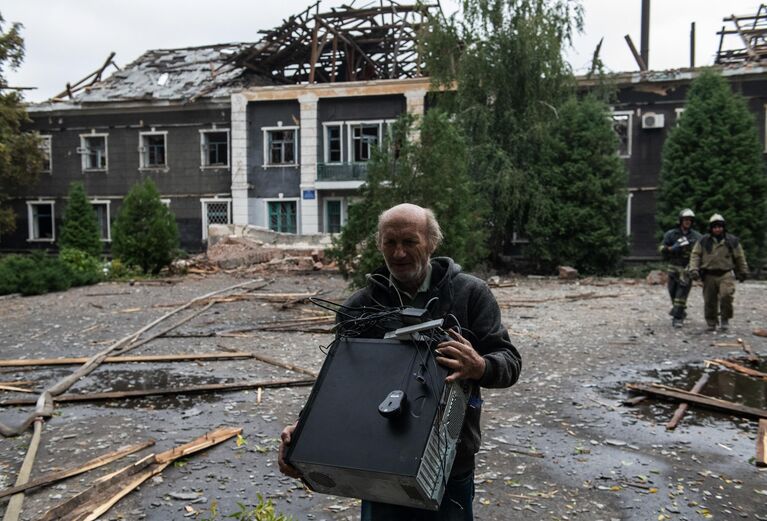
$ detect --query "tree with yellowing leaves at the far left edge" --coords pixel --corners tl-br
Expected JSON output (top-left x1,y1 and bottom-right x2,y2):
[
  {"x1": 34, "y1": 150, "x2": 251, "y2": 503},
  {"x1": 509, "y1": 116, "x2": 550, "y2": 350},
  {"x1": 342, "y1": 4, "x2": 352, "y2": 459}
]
[{"x1": 0, "y1": 15, "x2": 43, "y2": 235}]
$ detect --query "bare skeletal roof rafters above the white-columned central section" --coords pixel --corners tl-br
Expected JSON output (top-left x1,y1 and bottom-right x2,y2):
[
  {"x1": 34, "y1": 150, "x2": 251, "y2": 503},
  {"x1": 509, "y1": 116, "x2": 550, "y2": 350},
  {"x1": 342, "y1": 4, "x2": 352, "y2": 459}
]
[{"x1": 229, "y1": 0, "x2": 439, "y2": 84}]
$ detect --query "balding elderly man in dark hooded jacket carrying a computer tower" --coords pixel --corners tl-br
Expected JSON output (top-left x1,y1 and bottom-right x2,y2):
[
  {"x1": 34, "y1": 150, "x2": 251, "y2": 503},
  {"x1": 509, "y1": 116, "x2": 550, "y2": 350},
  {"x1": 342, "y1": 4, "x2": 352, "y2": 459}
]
[{"x1": 279, "y1": 204, "x2": 522, "y2": 521}]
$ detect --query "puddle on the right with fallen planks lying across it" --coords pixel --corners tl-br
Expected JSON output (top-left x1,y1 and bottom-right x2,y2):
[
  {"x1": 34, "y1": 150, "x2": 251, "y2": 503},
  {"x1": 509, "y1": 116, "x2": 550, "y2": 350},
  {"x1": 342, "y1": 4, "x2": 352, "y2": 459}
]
[{"x1": 634, "y1": 359, "x2": 767, "y2": 426}]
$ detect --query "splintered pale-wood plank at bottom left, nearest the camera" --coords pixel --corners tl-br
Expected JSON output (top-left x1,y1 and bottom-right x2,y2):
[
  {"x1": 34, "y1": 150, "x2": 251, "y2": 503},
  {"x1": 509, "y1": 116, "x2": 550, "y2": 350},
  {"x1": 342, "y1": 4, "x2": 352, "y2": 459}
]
[{"x1": 42, "y1": 427, "x2": 242, "y2": 521}]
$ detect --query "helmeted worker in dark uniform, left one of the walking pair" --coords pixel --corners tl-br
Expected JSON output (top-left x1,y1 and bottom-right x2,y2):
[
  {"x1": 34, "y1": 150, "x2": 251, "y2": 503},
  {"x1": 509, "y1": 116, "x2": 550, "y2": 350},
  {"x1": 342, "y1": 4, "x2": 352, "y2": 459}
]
[{"x1": 658, "y1": 208, "x2": 701, "y2": 327}]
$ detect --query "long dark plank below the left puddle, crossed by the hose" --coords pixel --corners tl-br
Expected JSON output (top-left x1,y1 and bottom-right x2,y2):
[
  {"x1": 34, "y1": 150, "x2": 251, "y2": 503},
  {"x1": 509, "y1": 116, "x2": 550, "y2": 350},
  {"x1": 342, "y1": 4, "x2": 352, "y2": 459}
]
[{"x1": 0, "y1": 378, "x2": 314, "y2": 407}]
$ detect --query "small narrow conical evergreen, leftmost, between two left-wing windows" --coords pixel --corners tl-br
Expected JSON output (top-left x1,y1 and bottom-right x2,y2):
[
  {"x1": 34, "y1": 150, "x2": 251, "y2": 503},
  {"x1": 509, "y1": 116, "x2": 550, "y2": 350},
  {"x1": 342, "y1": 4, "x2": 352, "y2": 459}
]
[{"x1": 58, "y1": 182, "x2": 103, "y2": 257}]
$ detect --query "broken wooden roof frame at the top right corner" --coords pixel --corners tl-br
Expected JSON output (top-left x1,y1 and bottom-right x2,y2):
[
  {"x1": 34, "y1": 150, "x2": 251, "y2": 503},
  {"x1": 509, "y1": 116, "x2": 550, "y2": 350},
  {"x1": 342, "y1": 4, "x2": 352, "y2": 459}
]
[{"x1": 715, "y1": 4, "x2": 767, "y2": 65}]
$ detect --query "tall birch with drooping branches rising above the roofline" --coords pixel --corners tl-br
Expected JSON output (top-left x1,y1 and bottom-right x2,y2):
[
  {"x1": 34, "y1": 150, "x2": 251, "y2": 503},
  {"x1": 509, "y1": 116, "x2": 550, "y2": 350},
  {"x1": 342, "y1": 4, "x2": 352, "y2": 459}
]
[{"x1": 425, "y1": 0, "x2": 582, "y2": 255}]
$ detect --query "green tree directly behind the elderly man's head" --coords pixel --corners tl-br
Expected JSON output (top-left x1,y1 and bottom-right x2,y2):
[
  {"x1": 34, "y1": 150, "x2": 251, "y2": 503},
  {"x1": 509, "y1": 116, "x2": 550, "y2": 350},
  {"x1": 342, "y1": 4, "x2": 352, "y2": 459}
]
[{"x1": 330, "y1": 109, "x2": 486, "y2": 286}]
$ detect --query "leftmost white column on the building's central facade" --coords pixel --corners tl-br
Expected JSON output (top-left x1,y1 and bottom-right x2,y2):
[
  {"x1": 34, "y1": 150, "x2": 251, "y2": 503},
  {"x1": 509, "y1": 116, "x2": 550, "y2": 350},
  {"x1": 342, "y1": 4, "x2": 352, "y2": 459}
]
[{"x1": 230, "y1": 94, "x2": 250, "y2": 225}]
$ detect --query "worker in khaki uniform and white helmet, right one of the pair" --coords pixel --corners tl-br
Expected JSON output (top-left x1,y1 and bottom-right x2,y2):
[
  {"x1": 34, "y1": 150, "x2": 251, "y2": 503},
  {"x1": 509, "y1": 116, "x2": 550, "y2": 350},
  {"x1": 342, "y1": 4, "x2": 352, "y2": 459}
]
[{"x1": 689, "y1": 213, "x2": 748, "y2": 331}]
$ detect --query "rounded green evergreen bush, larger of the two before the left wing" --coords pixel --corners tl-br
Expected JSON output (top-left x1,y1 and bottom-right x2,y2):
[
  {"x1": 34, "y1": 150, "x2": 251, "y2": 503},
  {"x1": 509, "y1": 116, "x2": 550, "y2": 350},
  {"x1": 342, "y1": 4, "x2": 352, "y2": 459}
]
[{"x1": 112, "y1": 178, "x2": 179, "y2": 274}]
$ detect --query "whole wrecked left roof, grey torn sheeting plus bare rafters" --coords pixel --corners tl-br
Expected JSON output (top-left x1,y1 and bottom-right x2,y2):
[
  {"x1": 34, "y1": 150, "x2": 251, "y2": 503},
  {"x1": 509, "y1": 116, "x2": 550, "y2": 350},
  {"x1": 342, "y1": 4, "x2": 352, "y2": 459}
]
[{"x1": 49, "y1": 0, "x2": 439, "y2": 105}]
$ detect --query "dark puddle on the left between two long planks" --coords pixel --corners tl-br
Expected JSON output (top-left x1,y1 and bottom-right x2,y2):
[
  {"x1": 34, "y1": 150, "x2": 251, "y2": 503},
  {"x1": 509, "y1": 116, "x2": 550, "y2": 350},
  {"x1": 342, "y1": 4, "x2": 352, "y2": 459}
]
[{"x1": 73, "y1": 369, "x2": 234, "y2": 409}]
